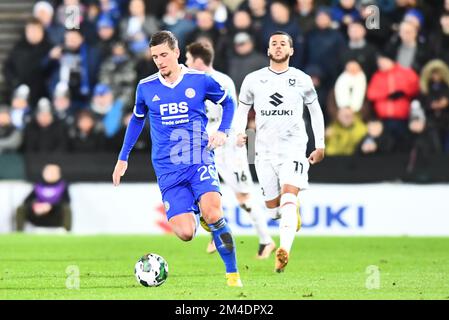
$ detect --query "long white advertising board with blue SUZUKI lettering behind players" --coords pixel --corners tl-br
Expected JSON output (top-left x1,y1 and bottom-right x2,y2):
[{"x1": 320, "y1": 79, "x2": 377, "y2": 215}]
[{"x1": 0, "y1": 182, "x2": 449, "y2": 236}]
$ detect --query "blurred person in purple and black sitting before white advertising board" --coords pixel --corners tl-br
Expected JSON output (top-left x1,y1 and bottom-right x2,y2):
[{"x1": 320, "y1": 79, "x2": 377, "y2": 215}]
[{"x1": 16, "y1": 164, "x2": 72, "y2": 231}]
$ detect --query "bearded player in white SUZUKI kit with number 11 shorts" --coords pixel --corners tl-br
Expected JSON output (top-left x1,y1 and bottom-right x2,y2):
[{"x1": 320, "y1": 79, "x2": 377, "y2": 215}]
[{"x1": 234, "y1": 31, "x2": 324, "y2": 272}]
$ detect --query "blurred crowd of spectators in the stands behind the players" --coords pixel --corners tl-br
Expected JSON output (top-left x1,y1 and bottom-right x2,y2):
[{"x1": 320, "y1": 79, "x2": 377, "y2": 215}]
[{"x1": 0, "y1": 0, "x2": 449, "y2": 156}]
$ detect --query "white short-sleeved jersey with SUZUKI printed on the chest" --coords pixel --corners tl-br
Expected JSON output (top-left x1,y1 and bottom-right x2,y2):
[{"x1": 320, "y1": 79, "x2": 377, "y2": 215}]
[{"x1": 239, "y1": 67, "x2": 318, "y2": 157}]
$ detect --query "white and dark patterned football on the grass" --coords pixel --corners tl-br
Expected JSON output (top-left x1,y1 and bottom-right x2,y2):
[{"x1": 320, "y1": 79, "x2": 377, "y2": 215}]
[{"x1": 134, "y1": 253, "x2": 168, "y2": 287}]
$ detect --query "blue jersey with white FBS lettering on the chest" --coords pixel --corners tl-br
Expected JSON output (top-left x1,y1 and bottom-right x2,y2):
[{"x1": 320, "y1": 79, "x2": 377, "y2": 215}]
[{"x1": 134, "y1": 66, "x2": 227, "y2": 177}]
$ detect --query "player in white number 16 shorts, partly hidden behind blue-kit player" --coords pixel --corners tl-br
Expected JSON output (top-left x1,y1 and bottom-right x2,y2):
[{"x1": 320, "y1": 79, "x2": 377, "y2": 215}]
[{"x1": 186, "y1": 40, "x2": 276, "y2": 259}]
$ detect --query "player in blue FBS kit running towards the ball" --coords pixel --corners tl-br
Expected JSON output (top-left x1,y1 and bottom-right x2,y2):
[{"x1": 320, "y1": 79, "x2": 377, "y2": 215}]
[{"x1": 112, "y1": 31, "x2": 242, "y2": 287}]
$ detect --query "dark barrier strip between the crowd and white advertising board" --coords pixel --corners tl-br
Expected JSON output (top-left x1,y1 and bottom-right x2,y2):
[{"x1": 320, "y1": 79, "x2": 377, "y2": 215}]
[{"x1": 0, "y1": 152, "x2": 449, "y2": 183}]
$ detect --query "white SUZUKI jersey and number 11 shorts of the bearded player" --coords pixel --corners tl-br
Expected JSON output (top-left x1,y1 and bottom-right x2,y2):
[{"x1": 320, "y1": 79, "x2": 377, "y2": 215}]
[{"x1": 240, "y1": 67, "x2": 324, "y2": 200}]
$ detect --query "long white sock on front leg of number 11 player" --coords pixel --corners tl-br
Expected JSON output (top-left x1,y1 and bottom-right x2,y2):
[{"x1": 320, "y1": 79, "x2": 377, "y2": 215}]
[{"x1": 279, "y1": 193, "x2": 298, "y2": 252}]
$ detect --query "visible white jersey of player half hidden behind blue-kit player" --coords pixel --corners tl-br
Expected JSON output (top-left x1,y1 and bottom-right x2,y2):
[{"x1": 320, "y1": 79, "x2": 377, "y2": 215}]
[{"x1": 205, "y1": 70, "x2": 237, "y2": 135}]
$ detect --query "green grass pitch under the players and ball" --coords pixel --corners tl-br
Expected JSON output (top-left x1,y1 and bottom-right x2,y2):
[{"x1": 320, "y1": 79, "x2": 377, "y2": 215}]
[{"x1": 0, "y1": 234, "x2": 449, "y2": 300}]
